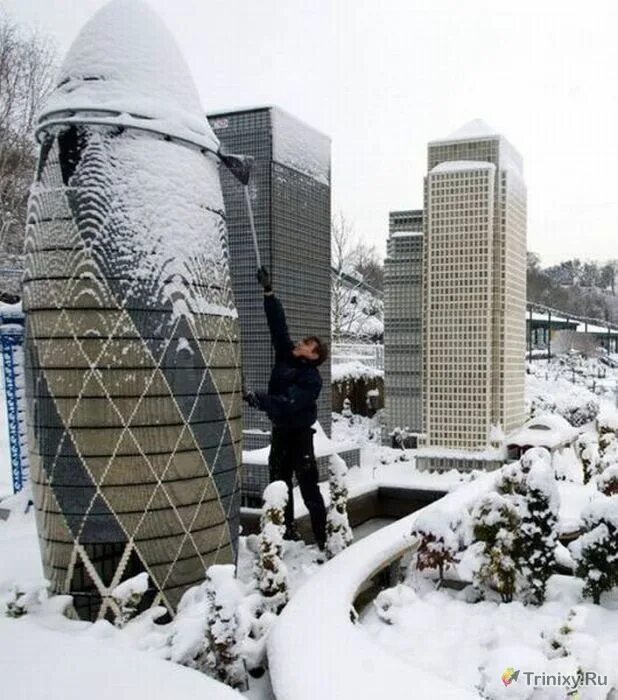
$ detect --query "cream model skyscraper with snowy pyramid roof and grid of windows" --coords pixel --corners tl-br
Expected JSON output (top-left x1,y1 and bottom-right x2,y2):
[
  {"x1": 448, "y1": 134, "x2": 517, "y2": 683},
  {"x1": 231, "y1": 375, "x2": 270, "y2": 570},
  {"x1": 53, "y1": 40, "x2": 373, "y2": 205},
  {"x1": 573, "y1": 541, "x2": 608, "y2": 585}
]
[{"x1": 423, "y1": 120, "x2": 526, "y2": 450}]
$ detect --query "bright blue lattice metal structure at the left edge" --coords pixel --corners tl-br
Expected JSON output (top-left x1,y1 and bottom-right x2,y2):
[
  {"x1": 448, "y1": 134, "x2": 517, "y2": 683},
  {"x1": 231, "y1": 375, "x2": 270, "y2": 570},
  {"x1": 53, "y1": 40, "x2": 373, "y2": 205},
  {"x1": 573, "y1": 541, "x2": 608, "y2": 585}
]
[{"x1": 0, "y1": 307, "x2": 28, "y2": 493}]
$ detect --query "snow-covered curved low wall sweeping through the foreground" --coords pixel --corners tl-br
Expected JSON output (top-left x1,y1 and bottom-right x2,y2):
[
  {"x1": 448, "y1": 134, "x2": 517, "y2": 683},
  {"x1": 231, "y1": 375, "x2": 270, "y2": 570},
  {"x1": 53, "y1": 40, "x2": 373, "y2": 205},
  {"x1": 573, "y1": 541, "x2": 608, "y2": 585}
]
[{"x1": 268, "y1": 472, "x2": 495, "y2": 700}]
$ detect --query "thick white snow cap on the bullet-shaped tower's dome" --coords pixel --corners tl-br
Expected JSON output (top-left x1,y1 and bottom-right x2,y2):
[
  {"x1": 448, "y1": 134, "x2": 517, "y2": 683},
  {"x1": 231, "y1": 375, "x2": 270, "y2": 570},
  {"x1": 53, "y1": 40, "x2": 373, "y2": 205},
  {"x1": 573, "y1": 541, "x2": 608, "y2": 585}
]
[{"x1": 38, "y1": 0, "x2": 219, "y2": 152}]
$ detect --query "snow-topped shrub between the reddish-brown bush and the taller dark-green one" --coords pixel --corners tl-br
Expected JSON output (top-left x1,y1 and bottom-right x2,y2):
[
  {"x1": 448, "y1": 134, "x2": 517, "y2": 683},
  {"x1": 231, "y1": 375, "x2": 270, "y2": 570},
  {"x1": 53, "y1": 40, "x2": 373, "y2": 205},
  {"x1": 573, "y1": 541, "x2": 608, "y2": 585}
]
[{"x1": 472, "y1": 493, "x2": 521, "y2": 603}]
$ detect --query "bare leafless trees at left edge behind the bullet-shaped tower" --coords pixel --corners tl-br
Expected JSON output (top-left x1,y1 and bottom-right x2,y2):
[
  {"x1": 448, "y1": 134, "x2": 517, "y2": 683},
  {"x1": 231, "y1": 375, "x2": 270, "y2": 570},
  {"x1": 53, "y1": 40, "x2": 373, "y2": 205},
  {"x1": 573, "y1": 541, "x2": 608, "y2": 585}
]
[{"x1": 0, "y1": 12, "x2": 56, "y2": 288}]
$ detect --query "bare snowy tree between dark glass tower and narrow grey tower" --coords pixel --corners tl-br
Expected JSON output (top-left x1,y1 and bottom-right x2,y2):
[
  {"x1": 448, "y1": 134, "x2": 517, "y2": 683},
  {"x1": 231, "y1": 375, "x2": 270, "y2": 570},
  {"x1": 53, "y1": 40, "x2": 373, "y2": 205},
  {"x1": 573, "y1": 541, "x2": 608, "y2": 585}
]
[{"x1": 331, "y1": 213, "x2": 383, "y2": 342}]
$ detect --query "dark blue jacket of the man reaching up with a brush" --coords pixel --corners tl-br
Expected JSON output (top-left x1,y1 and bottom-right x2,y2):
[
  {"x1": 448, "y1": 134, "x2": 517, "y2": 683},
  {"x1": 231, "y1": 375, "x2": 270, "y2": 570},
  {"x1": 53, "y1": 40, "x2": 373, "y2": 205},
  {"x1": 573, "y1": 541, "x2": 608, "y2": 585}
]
[{"x1": 255, "y1": 294, "x2": 322, "y2": 428}]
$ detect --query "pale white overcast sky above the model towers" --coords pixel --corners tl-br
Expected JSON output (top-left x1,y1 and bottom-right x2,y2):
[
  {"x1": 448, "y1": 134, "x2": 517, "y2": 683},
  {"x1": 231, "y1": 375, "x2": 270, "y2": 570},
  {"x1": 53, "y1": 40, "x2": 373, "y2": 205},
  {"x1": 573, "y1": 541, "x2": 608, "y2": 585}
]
[{"x1": 0, "y1": 0, "x2": 618, "y2": 264}]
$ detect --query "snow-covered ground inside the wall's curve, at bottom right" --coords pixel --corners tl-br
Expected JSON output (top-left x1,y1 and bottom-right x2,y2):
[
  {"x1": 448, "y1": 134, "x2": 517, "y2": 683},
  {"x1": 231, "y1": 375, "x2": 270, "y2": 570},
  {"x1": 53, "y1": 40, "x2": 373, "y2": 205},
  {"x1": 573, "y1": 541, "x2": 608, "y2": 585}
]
[{"x1": 363, "y1": 576, "x2": 618, "y2": 700}]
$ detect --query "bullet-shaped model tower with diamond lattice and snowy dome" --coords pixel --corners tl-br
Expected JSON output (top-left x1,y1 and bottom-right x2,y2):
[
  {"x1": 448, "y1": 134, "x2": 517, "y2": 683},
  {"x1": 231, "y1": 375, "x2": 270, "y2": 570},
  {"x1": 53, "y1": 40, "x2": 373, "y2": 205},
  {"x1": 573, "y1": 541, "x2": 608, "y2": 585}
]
[{"x1": 24, "y1": 0, "x2": 241, "y2": 618}]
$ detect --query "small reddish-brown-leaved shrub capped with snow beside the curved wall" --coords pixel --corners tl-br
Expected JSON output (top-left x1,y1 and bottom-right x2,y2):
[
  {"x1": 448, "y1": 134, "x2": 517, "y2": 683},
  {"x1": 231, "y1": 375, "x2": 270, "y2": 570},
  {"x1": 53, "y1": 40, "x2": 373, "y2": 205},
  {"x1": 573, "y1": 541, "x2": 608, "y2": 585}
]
[{"x1": 412, "y1": 510, "x2": 459, "y2": 585}]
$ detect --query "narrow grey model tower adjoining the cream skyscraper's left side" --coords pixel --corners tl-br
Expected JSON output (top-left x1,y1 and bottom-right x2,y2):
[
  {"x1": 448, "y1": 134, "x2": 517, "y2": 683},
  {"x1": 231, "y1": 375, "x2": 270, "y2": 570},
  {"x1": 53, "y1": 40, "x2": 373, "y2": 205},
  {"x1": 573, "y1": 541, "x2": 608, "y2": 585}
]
[{"x1": 384, "y1": 210, "x2": 423, "y2": 446}]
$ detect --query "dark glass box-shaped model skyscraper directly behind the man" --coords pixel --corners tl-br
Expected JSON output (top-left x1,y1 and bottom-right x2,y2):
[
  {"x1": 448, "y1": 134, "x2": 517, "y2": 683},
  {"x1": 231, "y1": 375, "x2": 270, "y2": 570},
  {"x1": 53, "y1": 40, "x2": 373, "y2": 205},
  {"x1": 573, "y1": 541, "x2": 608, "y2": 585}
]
[{"x1": 209, "y1": 107, "x2": 332, "y2": 505}]
